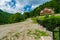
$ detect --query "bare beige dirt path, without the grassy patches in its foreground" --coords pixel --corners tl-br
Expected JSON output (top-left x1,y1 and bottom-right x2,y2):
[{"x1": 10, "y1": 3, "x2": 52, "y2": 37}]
[{"x1": 0, "y1": 19, "x2": 52, "y2": 40}]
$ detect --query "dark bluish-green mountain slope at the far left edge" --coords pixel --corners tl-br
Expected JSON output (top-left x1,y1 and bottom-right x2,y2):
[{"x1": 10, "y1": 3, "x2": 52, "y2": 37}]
[{"x1": 0, "y1": 10, "x2": 11, "y2": 24}]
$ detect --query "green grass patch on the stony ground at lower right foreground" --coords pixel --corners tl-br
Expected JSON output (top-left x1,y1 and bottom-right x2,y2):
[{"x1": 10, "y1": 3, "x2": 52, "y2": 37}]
[{"x1": 27, "y1": 29, "x2": 48, "y2": 39}]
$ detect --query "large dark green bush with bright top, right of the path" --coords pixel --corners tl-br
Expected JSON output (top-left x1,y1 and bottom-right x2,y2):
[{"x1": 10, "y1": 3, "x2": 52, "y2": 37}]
[{"x1": 37, "y1": 15, "x2": 60, "y2": 31}]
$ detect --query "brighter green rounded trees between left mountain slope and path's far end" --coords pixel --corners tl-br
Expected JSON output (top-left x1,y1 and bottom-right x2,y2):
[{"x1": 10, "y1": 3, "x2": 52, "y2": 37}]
[{"x1": 8, "y1": 13, "x2": 23, "y2": 23}]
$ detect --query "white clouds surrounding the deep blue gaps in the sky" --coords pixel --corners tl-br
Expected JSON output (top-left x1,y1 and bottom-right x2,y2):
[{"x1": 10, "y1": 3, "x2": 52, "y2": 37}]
[{"x1": 0, "y1": 0, "x2": 50, "y2": 13}]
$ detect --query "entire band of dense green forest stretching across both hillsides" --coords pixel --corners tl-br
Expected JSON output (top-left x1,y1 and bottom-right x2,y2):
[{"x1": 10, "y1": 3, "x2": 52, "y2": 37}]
[{"x1": 0, "y1": 0, "x2": 60, "y2": 24}]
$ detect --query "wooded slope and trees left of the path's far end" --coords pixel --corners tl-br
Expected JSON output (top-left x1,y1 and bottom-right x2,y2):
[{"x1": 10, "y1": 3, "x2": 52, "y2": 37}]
[{"x1": 0, "y1": 10, "x2": 30, "y2": 24}]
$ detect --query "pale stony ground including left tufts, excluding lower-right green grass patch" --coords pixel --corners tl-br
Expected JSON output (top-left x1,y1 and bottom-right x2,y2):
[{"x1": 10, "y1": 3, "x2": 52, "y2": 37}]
[{"x1": 0, "y1": 19, "x2": 53, "y2": 40}]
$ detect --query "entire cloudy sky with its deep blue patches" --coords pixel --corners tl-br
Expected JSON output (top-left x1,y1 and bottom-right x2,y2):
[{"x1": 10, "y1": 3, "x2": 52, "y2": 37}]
[{"x1": 0, "y1": 0, "x2": 49, "y2": 13}]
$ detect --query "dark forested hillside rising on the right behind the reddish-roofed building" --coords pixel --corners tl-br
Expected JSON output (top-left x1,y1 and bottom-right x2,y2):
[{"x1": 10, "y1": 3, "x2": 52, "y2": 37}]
[{"x1": 31, "y1": 0, "x2": 60, "y2": 16}]
